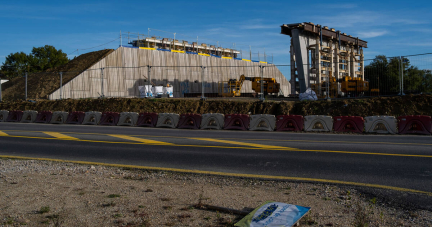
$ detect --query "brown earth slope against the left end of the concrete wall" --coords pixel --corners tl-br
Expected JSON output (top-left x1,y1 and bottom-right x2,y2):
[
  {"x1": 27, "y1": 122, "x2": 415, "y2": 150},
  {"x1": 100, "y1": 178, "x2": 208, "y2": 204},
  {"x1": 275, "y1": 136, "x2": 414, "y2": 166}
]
[{"x1": 2, "y1": 49, "x2": 114, "y2": 101}]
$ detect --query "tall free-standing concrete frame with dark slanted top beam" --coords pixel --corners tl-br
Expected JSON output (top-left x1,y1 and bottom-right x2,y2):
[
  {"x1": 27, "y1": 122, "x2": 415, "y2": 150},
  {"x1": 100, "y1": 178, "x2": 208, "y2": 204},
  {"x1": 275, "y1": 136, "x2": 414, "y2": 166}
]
[{"x1": 281, "y1": 22, "x2": 367, "y2": 96}]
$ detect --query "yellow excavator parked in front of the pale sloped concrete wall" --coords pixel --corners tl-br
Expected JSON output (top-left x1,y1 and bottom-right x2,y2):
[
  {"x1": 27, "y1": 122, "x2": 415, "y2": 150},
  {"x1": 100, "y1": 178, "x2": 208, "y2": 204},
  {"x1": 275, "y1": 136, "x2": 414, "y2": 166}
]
[{"x1": 218, "y1": 75, "x2": 280, "y2": 97}]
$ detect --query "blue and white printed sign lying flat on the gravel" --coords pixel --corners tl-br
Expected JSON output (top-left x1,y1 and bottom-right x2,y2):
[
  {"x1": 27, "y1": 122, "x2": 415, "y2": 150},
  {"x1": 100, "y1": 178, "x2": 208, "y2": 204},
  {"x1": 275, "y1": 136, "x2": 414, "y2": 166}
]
[{"x1": 234, "y1": 201, "x2": 310, "y2": 227}]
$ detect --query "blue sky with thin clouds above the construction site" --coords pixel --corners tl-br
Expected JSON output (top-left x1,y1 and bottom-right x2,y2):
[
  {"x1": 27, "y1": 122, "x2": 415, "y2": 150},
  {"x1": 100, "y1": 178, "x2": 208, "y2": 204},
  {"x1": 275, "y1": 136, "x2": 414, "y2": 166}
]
[{"x1": 0, "y1": 0, "x2": 432, "y2": 68}]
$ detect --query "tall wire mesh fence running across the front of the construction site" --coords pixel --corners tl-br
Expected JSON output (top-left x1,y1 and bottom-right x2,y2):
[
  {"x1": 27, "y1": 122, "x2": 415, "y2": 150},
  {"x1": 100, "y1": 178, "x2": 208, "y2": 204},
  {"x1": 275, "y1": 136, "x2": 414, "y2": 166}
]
[{"x1": 1, "y1": 54, "x2": 432, "y2": 100}]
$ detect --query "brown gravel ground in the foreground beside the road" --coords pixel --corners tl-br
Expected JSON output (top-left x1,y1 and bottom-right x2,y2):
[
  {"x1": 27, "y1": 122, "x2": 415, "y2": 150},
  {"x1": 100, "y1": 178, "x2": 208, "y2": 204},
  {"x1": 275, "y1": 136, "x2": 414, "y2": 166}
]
[{"x1": 0, "y1": 159, "x2": 432, "y2": 226}]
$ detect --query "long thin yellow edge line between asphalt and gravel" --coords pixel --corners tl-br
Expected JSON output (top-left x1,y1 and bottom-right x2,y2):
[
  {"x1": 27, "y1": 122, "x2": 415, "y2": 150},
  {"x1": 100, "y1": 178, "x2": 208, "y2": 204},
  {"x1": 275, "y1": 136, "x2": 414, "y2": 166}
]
[{"x1": 0, "y1": 155, "x2": 432, "y2": 196}]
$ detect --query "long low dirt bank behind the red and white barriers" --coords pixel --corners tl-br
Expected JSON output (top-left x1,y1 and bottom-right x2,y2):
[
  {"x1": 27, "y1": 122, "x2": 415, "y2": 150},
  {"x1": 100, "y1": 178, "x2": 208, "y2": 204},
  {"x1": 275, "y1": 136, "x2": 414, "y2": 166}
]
[{"x1": 0, "y1": 95, "x2": 432, "y2": 116}]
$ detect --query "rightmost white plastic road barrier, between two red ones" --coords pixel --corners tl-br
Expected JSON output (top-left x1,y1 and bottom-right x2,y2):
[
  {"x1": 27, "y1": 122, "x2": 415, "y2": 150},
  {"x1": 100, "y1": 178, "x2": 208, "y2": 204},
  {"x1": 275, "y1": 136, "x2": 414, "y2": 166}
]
[{"x1": 365, "y1": 116, "x2": 398, "y2": 134}]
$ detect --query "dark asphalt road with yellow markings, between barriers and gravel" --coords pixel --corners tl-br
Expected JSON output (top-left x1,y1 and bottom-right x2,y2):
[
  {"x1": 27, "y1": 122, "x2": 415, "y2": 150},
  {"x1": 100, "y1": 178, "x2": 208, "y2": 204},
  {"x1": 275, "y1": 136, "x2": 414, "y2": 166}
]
[{"x1": 0, "y1": 122, "x2": 432, "y2": 208}]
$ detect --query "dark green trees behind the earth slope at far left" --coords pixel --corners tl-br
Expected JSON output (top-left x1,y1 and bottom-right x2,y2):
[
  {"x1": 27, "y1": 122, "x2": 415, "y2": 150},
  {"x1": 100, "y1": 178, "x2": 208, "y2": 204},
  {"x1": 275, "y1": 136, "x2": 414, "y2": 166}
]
[{"x1": 1, "y1": 45, "x2": 69, "y2": 78}]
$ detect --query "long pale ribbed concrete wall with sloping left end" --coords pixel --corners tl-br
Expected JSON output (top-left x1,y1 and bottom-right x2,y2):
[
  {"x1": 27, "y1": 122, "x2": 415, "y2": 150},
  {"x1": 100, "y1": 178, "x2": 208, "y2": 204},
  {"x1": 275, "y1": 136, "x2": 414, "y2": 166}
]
[{"x1": 48, "y1": 47, "x2": 290, "y2": 100}]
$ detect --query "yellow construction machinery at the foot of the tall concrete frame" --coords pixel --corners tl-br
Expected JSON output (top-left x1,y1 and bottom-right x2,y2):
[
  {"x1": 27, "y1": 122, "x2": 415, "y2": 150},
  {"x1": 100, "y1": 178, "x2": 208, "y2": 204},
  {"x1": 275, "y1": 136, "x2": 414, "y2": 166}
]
[{"x1": 311, "y1": 72, "x2": 379, "y2": 98}]
